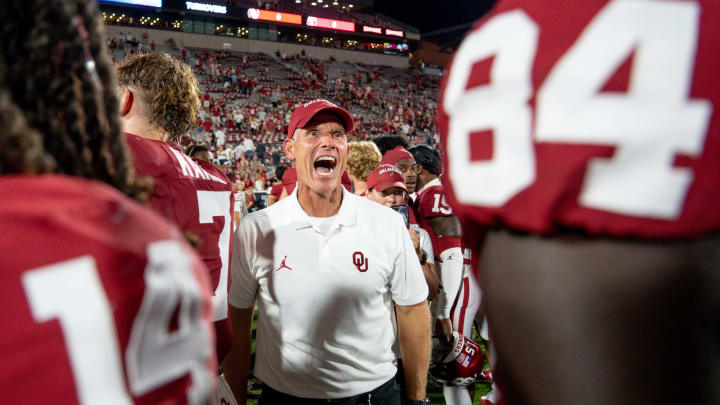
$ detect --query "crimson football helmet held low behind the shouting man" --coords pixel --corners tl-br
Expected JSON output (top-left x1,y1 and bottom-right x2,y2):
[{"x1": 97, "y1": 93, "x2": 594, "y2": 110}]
[{"x1": 429, "y1": 332, "x2": 483, "y2": 386}]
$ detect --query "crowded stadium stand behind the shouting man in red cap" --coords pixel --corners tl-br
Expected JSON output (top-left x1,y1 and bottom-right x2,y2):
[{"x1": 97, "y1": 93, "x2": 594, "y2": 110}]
[{"x1": 108, "y1": 37, "x2": 438, "y2": 200}]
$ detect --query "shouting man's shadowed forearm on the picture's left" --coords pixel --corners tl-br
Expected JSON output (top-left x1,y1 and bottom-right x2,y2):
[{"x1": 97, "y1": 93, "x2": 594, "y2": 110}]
[{"x1": 222, "y1": 304, "x2": 254, "y2": 404}]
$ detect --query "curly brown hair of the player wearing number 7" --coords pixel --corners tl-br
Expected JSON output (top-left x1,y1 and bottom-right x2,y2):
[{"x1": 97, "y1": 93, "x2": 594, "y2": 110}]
[{"x1": 118, "y1": 52, "x2": 200, "y2": 142}]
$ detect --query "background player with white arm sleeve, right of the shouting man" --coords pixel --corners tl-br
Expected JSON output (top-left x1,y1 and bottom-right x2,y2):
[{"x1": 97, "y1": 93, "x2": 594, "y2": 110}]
[{"x1": 408, "y1": 145, "x2": 481, "y2": 405}]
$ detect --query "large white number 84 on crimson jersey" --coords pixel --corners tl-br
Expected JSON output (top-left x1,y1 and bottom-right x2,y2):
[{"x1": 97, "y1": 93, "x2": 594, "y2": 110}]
[{"x1": 444, "y1": 0, "x2": 712, "y2": 219}]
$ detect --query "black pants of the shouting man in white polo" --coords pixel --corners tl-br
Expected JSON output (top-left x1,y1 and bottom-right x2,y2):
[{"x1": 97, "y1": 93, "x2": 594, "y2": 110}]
[{"x1": 258, "y1": 378, "x2": 400, "y2": 405}]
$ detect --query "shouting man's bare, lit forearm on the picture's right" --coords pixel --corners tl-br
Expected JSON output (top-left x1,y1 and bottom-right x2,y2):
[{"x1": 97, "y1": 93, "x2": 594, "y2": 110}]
[{"x1": 395, "y1": 301, "x2": 430, "y2": 400}]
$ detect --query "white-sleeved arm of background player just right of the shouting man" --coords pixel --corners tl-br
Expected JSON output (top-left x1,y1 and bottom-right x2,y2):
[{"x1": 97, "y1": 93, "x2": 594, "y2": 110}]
[{"x1": 430, "y1": 215, "x2": 463, "y2": 338}]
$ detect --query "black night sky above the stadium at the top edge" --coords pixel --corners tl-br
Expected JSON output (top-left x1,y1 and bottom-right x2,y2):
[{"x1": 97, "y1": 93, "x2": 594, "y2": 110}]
[{"x1": 375, "y1": 0, "x2": 495, "y2": 33}]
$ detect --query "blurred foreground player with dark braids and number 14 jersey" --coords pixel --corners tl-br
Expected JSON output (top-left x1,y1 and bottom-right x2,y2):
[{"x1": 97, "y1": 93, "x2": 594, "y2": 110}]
[{"x1": 0, "y1": 0, "x2": 216, "y2": 404}]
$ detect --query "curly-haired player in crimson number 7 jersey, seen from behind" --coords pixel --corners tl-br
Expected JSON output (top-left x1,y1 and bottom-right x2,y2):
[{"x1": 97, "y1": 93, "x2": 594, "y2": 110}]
[{"x1": 117, "y1": 52, "x2": 233, "y2": 361}]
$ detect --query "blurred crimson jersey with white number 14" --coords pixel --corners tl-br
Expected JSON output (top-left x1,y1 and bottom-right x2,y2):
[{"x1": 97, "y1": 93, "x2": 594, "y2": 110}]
[{"x1": 0, "y1": 175, "x2": 216, "y2": 405}]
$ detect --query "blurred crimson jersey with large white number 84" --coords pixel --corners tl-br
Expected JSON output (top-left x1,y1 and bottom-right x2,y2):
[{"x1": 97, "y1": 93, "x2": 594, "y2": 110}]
[{"x1": 438, "y1": 0, "x2": 720, "y2": 238}]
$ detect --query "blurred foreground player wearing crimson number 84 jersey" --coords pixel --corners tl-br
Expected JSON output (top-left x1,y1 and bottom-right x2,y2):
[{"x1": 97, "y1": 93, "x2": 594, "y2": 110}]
[{"x1": 438, "y1": 0, "x2": 720, "y2": 405}]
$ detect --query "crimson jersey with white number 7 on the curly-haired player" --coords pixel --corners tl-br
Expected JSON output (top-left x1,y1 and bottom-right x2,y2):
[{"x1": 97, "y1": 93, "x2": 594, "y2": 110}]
[{"x1": 126, "y1": 134, "x2": 234, "y2": 320}]
